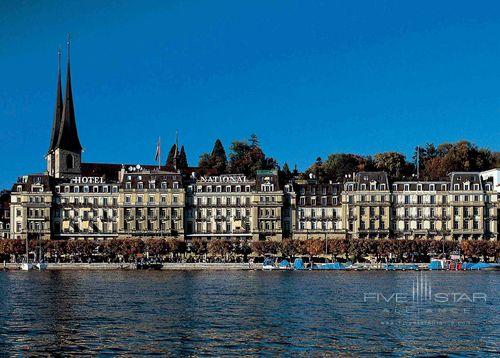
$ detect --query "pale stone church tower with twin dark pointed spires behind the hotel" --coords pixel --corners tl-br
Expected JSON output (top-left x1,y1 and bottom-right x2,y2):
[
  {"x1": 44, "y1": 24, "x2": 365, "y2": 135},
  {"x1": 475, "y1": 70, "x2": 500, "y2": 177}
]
[{"x1": 47, "y1": 39, "x2": 82, "y2": 178}]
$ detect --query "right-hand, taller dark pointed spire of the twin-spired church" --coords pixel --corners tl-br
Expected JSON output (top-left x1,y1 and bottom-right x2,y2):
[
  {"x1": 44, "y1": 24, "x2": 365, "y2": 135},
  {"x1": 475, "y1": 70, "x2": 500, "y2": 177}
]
[{"x1": 56, "y1": 36, "x2": 82, "y2": 152}]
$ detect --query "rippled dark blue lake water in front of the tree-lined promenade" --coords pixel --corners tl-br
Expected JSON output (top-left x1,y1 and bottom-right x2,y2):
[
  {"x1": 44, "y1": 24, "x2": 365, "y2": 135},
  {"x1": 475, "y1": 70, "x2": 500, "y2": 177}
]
[{"x1": 0, "y1": 271, "x2": 500, "y2": 356}]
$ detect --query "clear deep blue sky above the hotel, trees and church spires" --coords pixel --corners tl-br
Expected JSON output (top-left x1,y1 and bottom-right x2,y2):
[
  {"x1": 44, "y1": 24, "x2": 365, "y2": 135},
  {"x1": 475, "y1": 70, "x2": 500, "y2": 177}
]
[{"x1": 0, "y1": 0, "x2": 500, "y2": 187}]
